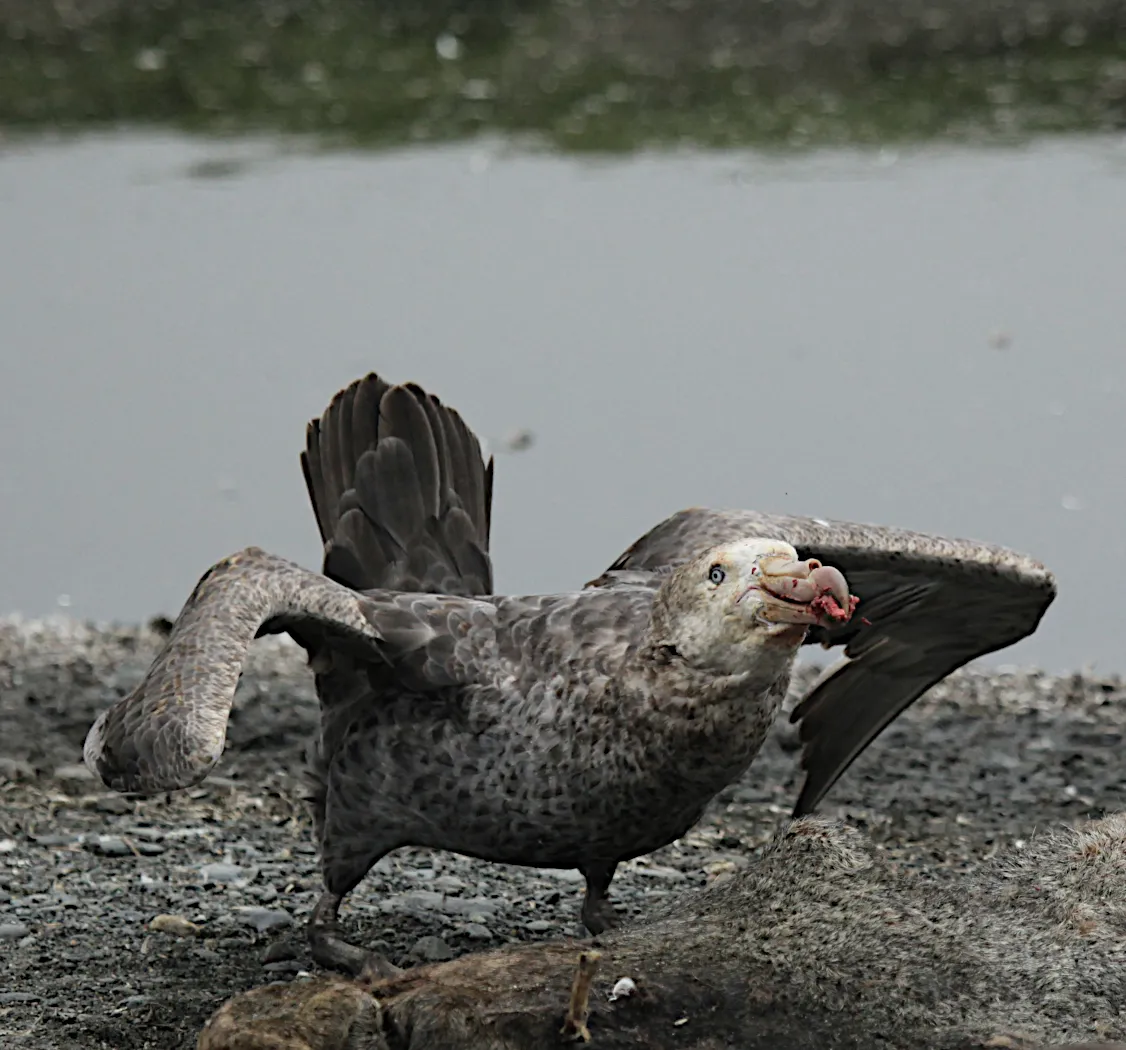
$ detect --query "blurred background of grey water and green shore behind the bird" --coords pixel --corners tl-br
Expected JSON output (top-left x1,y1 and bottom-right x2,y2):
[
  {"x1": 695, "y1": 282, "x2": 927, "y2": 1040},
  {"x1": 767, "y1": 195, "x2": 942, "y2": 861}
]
[{"x1": 0, "y1": 0, "x2": 1126, "y2": 673}]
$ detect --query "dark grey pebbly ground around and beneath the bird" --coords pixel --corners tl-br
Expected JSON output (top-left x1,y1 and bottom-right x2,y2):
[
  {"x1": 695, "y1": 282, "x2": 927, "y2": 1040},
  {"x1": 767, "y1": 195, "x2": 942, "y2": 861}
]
[{"x1": 0, "y1": 622, "x2": 1126, "y2": 1050}]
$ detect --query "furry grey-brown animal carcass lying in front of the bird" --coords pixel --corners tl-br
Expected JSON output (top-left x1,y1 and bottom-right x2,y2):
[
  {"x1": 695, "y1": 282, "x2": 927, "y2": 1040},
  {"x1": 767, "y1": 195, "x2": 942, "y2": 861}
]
[{"x1": 199, "y1": 815, "x2": 1126, "y2": 1050}]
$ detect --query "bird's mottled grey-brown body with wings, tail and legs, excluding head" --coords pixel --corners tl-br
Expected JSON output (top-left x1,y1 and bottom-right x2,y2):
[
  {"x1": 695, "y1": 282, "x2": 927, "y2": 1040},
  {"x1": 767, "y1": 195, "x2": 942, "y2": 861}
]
[{"x1": 86, "y1": 375, "x2": 1054, "y2": 968}]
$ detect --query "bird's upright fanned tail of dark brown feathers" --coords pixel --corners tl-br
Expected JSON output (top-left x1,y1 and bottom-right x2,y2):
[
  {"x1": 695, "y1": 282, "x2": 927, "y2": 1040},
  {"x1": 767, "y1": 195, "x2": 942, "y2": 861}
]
[{"x1": 301, "y1": 373, "x2": 493, "y2": 595}]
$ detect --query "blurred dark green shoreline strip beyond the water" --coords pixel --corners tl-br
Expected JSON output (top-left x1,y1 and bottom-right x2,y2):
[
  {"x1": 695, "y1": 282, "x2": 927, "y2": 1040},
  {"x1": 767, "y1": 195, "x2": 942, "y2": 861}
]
[{"x1": 0, "y1": 0, "x2": 1126, "y2": 151}]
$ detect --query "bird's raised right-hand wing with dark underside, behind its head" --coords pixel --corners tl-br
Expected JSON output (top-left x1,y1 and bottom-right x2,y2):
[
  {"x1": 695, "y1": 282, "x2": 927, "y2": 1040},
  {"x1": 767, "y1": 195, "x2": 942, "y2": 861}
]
[{"x1": 595, "y1": 508, "x2": 1056, "y2": 816}]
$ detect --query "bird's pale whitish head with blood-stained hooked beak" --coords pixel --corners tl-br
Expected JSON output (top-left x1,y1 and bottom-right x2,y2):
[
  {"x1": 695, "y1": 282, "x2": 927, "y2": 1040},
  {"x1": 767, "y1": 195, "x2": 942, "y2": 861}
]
[{"x1": 654, "y1": 538, "x2": 858, "y2": 674}]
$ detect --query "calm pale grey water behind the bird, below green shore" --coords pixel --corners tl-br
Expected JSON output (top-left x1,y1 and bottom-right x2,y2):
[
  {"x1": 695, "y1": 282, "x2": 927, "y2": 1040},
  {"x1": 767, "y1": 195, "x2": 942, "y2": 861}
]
[{"x1": 0, "y1": 134, "x2": 1126, "y2": 673}]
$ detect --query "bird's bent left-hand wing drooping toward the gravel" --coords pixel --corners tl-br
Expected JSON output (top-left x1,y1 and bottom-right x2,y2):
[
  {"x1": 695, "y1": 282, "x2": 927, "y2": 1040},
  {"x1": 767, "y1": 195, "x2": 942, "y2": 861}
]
[{"x1": 83, "y1": 547, "x2": 495, "y2": 793}]
